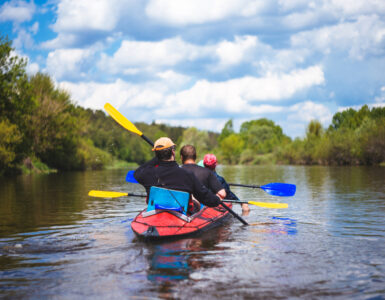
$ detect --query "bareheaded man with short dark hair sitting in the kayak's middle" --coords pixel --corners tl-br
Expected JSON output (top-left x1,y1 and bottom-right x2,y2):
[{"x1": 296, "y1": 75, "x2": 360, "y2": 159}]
[{"x1": 180, "y1": 145, "x2": 226, "y2": 199}]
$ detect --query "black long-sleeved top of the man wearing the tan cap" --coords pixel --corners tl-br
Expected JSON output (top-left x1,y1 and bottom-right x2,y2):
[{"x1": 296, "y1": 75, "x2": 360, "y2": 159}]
[{"x1": 134, "y1": 157, "x2": 220, "y2": 207}]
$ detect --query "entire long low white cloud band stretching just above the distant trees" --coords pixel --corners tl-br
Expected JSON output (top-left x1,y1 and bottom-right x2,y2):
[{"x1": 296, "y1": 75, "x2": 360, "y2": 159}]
[{"x1": 57, "y1": 66, "x2": 323, "y2": 125}]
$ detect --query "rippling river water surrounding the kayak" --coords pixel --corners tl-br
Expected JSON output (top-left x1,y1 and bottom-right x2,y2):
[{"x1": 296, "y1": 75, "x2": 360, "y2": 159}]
[{"x1": 0, "y1": 166, "x2": 385, "y2": 299}]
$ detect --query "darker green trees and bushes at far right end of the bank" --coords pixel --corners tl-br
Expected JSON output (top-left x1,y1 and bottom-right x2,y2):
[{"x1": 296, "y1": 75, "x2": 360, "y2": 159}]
[{"x1": 279, "y1": 105, "x2": 385, "y2": 165}]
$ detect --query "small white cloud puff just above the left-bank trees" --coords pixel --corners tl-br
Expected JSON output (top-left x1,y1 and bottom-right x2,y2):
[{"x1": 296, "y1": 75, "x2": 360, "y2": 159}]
[{"x1": 46, "y1": 49, "x2": 94, "y2": 79}]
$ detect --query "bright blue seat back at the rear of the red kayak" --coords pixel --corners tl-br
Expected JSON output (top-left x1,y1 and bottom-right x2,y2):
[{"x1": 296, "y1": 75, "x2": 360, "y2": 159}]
[{"x1": 147, "y1": 186, "x2": 190, "y2": 215}]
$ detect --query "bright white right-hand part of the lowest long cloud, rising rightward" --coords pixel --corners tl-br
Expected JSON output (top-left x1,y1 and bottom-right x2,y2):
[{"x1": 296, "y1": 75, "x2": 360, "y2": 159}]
[{"x1": 156, "y1": 66, "x2": 324, "y2": 117}]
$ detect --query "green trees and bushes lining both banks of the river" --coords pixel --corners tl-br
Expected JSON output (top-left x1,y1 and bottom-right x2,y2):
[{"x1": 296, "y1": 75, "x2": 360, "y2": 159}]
[{"x1": 0, "y1": 36, "x2": 385, "y2": 176}]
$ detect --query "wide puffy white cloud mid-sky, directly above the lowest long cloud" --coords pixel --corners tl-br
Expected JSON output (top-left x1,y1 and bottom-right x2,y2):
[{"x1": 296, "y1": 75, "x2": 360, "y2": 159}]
[{"x1": 98, "y1": 35, "x2": 310, "y2": 75}]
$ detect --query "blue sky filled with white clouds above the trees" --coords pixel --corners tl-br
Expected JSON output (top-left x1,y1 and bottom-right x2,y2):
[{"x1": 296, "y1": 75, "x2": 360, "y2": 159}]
[{"x1": 0, "y1": 0, "x2": 385, "y2": 138}]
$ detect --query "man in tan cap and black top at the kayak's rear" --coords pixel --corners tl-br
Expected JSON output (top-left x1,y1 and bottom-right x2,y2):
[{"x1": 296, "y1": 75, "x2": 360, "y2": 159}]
[{"x1": 134, "y1": 137, "x2": 221, "y2": 213}]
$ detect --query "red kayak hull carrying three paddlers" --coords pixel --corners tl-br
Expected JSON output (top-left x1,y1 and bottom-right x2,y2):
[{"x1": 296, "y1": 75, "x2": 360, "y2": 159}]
[{"x1": 131, "y1": 204, "x2": 232, "y2": 240}]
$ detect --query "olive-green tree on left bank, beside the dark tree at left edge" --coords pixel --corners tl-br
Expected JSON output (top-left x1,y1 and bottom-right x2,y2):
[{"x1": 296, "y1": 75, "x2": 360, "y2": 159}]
[{"x1": 30, "y1": 73, "x2": 84, "y2": 170}]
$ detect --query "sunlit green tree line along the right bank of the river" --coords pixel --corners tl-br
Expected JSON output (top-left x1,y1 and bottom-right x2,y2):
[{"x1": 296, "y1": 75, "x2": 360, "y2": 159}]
[{"x1": 214, "y1": 105, "x2": 385, "y2": 165}]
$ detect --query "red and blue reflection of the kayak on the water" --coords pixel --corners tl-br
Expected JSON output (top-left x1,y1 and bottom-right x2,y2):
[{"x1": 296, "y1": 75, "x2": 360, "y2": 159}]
[{"x1": 147, "y1": 227, "x2": 230, "y2": 286}]
